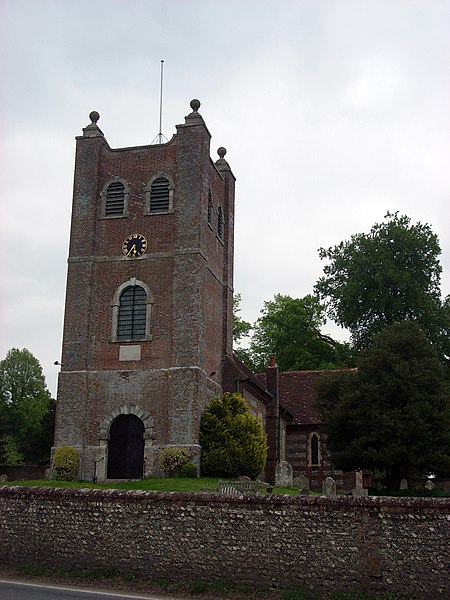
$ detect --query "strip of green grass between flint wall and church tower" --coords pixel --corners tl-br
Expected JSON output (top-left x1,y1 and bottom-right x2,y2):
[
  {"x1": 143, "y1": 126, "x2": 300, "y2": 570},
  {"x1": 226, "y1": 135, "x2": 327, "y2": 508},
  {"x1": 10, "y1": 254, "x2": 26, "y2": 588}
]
[{"x1": 3, "y1": 477, "x2": 304, "y2": 495}]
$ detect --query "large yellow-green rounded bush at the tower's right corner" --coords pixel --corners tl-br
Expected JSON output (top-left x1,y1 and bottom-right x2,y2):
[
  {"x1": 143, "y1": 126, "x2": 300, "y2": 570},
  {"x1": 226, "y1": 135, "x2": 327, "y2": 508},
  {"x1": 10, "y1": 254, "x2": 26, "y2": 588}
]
[{"x1": 200, "y1": 394, "x2": 267, "y2": 479}]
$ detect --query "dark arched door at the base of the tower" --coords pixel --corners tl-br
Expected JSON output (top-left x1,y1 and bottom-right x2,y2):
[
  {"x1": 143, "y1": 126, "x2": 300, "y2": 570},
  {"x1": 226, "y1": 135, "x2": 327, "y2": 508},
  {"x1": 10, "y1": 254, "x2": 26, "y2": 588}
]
[{"x1": 107, "y1": 415, "x2": 145, "y2": 479}]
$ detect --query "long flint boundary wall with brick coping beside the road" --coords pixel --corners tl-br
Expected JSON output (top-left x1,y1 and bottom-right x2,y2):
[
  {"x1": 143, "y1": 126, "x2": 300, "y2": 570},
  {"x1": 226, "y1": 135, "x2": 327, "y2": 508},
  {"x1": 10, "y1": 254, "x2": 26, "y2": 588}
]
[{"x1": 0, "y1": 486, "x2": 450, "y2": 600}]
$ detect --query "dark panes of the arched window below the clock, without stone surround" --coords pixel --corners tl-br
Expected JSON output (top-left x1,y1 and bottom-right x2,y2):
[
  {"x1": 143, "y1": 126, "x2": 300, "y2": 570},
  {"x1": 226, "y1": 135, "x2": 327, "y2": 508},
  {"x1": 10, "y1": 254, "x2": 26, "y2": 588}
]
[{"x1": 117, "y1": 285, "x2": 147, "y2": 340}]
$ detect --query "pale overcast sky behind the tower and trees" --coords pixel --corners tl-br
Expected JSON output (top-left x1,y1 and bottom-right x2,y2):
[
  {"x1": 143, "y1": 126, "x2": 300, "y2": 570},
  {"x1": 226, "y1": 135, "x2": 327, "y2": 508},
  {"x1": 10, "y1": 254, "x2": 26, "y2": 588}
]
[{"x1": 0, "y1": 0, "x2": 450, "y2": 394}]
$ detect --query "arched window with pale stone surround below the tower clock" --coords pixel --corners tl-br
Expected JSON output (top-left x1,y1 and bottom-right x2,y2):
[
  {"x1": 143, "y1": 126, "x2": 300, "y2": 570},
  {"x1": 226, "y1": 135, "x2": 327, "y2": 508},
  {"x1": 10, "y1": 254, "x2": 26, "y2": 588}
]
[{"x1": 112, "y1": 277, "x2": 153, "y2": 341}]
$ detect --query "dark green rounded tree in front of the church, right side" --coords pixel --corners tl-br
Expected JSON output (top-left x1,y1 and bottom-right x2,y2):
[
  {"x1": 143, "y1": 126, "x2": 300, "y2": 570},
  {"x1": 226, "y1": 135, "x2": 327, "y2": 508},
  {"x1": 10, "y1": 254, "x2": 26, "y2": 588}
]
[{"x1": 317, "y1": 321, "x2": 450, "y2": 488}]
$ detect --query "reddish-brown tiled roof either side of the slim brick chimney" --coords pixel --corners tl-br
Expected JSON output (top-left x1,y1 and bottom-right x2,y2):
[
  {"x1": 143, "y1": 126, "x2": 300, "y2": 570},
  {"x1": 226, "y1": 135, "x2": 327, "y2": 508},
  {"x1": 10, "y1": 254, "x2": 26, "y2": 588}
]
[{"x1": 257, "y1": 370, "x2": 342, "y2": 425}]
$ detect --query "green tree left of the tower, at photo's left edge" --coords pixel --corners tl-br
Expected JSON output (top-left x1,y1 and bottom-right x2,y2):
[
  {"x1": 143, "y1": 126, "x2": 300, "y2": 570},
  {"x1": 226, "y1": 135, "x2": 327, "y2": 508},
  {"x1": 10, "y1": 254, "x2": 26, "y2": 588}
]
[{"x1": 0, "y1": 348, "x2": 54, "y2": 463}]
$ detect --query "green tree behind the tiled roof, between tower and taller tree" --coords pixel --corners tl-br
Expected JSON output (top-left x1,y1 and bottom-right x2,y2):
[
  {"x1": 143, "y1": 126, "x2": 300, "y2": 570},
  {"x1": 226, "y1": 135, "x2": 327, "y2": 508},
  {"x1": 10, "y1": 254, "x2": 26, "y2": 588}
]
[{"x1": 250, "y1": 294, "x2": 352, "y2": 371}]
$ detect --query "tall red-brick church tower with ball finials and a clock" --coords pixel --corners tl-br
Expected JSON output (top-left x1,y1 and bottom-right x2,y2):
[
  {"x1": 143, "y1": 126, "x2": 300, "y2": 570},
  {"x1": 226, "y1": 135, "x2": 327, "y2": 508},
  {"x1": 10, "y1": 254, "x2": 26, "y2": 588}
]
[{"x1": 55, "y1": 100, "x2": 235, "y2": 481}]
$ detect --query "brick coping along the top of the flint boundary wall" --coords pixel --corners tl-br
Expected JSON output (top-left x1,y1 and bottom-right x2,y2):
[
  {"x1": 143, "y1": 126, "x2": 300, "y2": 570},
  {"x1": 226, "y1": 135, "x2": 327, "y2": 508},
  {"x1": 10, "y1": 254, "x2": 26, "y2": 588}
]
[{"x1": 0, "y1": 485, "x2": 450, "y2": 514}]
